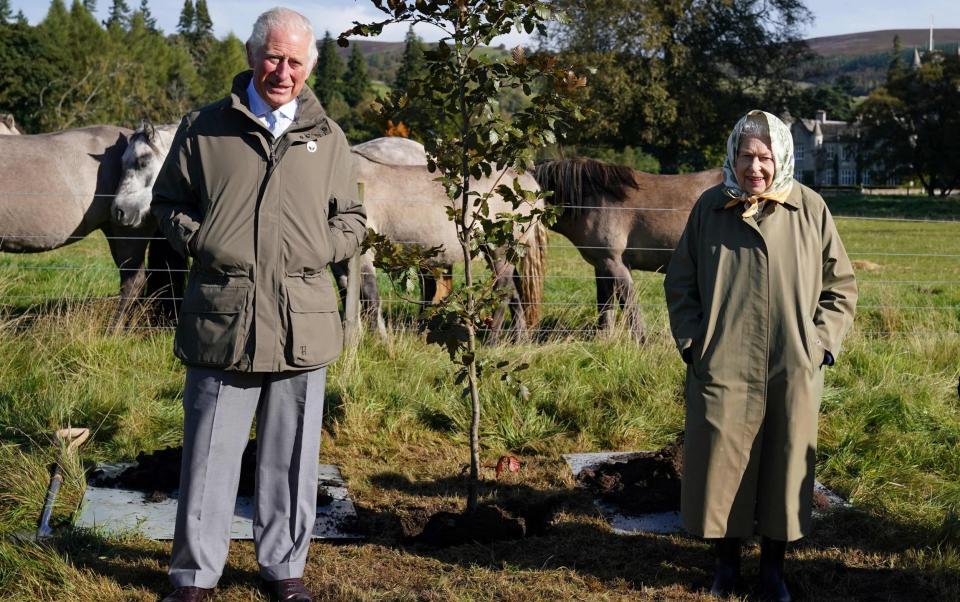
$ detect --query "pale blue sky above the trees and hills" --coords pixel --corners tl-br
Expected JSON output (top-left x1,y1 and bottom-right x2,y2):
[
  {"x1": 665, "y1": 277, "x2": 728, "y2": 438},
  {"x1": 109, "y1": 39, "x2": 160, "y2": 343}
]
[{"x1": 11, "y1": 0, "x2": 960, "y2": 47}]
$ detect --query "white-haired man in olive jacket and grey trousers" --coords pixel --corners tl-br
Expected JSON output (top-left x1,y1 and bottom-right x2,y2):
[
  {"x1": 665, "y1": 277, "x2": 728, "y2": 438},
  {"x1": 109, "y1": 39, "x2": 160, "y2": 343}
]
[{"x1": 151, "y1": 8, "x2": 366, "y2": 602}]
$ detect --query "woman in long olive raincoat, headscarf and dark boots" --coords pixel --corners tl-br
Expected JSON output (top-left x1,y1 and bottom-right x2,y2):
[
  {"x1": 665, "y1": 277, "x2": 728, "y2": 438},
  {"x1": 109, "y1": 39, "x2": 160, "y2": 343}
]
[{"x1": 664, "y1": 111, "x2": 857, "y2": 600}]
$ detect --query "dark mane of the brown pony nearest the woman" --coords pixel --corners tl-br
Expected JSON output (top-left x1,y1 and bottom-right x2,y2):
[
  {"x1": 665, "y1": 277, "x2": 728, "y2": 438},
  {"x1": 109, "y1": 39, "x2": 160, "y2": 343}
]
[{"x1": 534, "y1": 157, "x2": 639, "y2": 216}]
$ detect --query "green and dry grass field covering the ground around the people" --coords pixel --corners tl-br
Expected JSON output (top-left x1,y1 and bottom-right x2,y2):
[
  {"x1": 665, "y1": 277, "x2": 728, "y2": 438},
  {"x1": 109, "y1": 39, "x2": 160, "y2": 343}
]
[{"x1": 0, "y1": 196, "x2": 960, "y2": 601}]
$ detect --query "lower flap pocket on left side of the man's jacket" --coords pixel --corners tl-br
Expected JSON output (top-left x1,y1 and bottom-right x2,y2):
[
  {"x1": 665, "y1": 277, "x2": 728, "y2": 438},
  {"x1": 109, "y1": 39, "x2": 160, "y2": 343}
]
[{"x1": 174, "y1": 281, "x2": 250, "y2": 368}]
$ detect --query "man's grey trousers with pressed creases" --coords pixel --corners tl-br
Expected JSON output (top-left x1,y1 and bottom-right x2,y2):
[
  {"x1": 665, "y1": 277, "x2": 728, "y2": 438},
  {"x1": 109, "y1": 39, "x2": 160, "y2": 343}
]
[{"x1": 169, "y1": 367, "x2": 326, "y2": 588}]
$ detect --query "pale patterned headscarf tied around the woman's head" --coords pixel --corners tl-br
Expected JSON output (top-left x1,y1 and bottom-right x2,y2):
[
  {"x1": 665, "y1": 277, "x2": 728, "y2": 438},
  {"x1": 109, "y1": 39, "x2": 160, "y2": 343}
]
[{"x1": 723, "y1": 109, "x2": 794, "y2": 218}]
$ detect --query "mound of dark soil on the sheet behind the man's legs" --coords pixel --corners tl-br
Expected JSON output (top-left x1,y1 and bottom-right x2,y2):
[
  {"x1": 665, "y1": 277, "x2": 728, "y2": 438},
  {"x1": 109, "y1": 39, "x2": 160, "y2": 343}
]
[{"x1": 90, "y1": 440, "x2": 333, "y2": 506}]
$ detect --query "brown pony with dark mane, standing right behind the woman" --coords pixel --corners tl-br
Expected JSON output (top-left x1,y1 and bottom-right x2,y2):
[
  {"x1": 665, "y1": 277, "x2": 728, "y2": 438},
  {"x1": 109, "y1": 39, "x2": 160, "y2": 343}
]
[{"x1": 535, "y1": 158, "x2": 723, "y2": 341}]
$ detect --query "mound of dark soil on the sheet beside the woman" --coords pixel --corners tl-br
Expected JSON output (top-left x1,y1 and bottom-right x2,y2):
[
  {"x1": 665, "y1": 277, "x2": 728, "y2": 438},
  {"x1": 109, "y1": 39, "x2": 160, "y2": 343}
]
[{"x1": 577, "y1": 442, "x2": 683, "y2": 514}]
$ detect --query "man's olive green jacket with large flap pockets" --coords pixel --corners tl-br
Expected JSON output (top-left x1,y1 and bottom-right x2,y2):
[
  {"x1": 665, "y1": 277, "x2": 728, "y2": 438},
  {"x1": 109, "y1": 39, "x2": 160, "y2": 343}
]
[{"x1": 151, "y1": 72, "x2": 366, "y2": 372}]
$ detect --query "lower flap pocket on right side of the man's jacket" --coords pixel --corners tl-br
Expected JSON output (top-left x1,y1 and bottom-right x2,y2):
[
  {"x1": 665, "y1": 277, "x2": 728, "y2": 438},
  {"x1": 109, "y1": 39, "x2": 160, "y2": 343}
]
[{"x1": 285, "y1": 271, "x2": 343, "y2": 368}]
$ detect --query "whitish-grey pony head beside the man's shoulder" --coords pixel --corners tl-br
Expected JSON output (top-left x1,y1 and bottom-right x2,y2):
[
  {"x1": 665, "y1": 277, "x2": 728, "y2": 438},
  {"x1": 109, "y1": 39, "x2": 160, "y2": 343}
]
[{"x1": 116, "y1": 121, "x2": 176, "y2": 228}]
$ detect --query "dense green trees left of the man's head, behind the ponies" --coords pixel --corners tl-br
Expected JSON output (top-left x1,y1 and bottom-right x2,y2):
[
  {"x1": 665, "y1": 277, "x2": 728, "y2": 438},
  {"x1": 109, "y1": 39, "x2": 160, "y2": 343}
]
[{"x1": 0, "y1": 0, "x2": 246, "y2": 133}]
